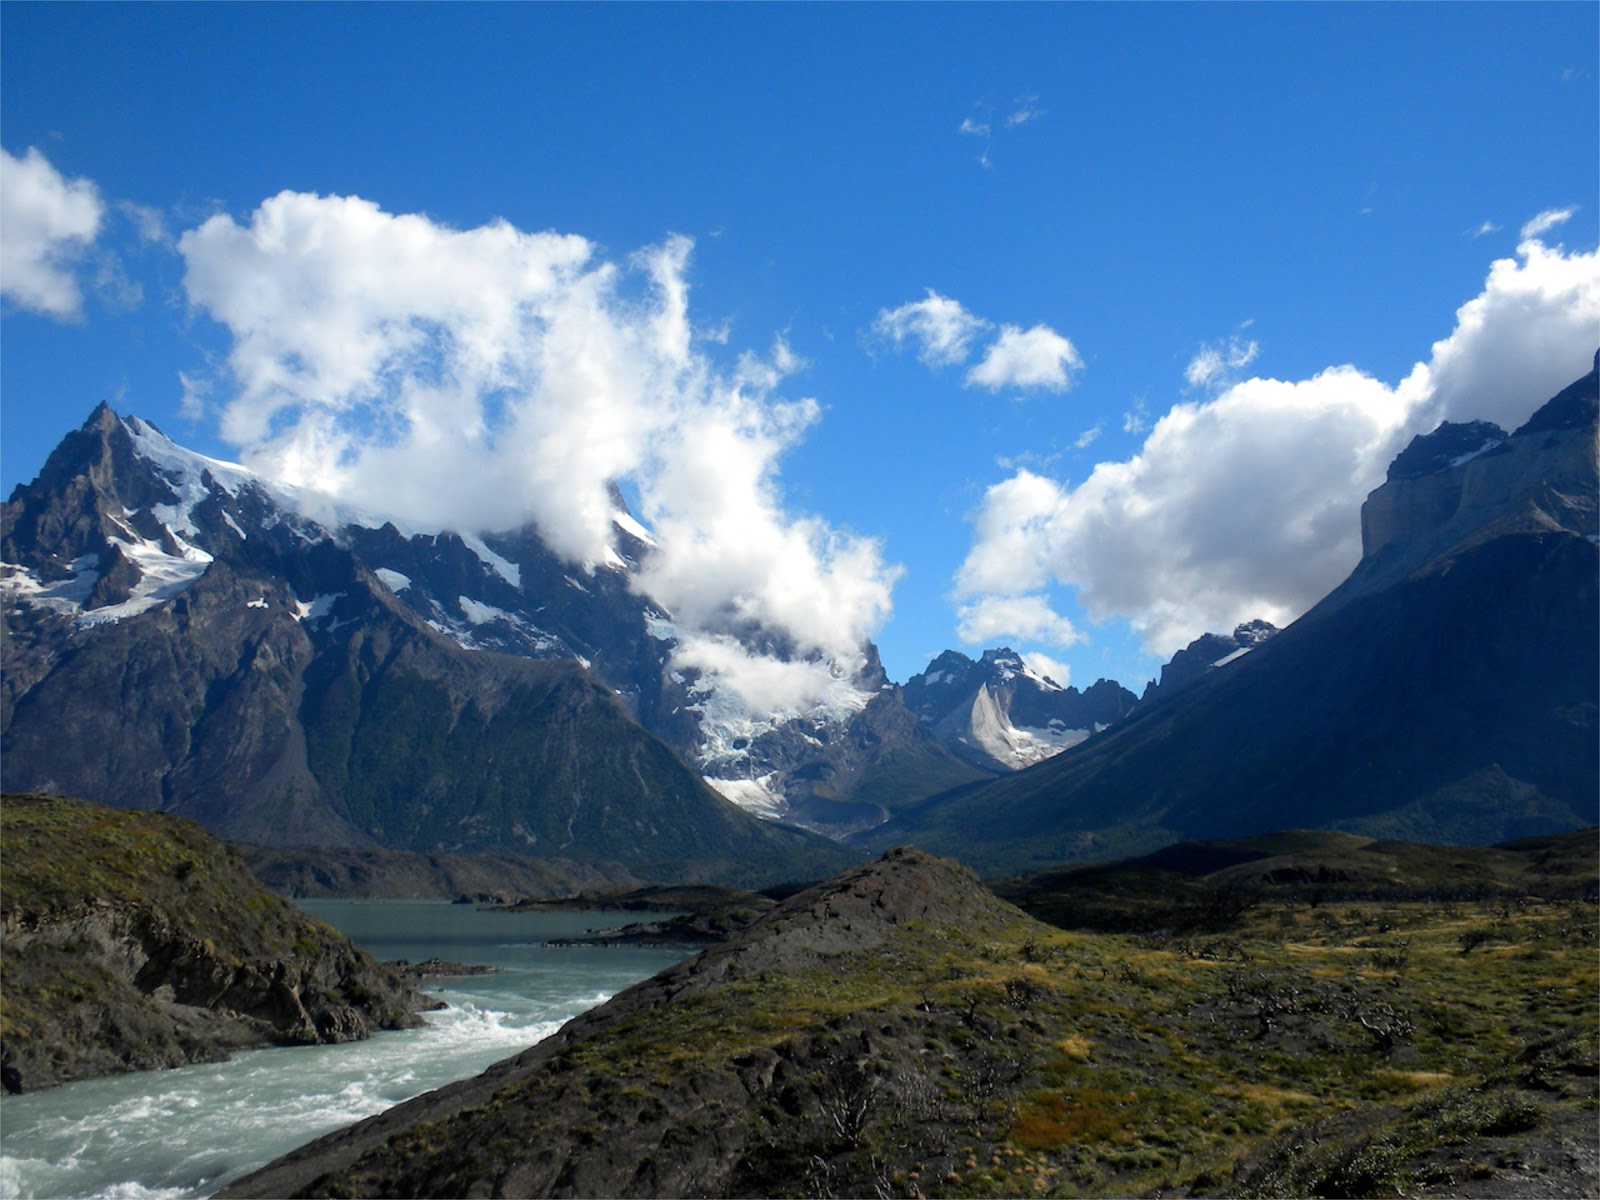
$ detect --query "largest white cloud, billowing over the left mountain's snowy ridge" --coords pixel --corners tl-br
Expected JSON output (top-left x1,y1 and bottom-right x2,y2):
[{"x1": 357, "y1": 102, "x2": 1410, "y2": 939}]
[{"x1": 178, "y1": 192, "x2": 898, "y2": 710}]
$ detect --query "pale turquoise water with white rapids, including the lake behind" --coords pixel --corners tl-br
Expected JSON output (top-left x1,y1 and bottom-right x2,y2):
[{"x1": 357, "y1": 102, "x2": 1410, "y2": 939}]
[{"x1": 0, "y1": 901, "x2": 683, "y2": 1200}]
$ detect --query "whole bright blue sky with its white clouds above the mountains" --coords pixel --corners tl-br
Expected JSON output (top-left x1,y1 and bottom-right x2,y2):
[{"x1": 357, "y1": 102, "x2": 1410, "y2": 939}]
[{"x1": 0, "y1": 3, "x2": 1600, "y2": 690}]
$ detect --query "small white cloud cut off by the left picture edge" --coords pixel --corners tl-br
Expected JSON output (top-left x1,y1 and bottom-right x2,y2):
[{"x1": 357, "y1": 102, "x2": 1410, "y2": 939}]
[{"x1": 0, "y1": 147, "x2": 106, "y2": 320}]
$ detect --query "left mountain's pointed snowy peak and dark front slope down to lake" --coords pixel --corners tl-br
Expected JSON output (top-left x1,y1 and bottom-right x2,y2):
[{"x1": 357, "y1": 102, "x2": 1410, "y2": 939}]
[{"x1": 0, "y1": 410, "x2": 840, "y2": 878}]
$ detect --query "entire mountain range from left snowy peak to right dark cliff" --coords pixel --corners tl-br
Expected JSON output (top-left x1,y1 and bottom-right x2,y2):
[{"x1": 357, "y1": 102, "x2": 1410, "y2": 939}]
[{"x1": 0, "y1": 352, "x2": 1600, "y2": 883}]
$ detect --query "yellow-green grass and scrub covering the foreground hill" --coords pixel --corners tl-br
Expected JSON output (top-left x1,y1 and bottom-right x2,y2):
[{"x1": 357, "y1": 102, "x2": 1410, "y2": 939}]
[{"x1": 305, "y1": 870, "x2": 1600, "y2": 1197}]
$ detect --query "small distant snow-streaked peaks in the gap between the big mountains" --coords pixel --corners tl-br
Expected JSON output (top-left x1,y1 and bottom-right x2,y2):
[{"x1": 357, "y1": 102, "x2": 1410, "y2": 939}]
[{"x1": 906, "y1": 646, "x2": 1136, "y2": 771}]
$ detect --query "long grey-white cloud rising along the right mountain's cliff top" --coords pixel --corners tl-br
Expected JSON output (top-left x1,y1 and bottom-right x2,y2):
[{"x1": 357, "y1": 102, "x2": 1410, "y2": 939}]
[{"x1": 955, "y1": 225, "x2": 1600, "y2": 656}]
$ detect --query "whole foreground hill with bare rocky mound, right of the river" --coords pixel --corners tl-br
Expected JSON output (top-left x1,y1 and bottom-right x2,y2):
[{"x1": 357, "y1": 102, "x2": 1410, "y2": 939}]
[{"x1": 229, "y1": 846, "x2": 1600, "y2": 1197}]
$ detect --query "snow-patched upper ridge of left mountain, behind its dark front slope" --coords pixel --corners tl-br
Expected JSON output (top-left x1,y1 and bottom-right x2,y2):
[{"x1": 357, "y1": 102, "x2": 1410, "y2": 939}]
[{"x1": 0, "y1": 405, "x2": 973, "y2": 830}]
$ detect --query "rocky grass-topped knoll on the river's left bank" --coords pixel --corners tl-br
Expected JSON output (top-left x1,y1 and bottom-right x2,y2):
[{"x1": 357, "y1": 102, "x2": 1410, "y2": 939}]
[{"x1": 0, "y1": 795, "x2": 427, "y2": 1091}]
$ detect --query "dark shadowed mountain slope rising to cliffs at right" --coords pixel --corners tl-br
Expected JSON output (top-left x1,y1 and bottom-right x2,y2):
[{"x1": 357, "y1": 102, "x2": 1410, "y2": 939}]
[{"x1": 874, "y1": 356, "x2": 1600, "y2": 870}]
